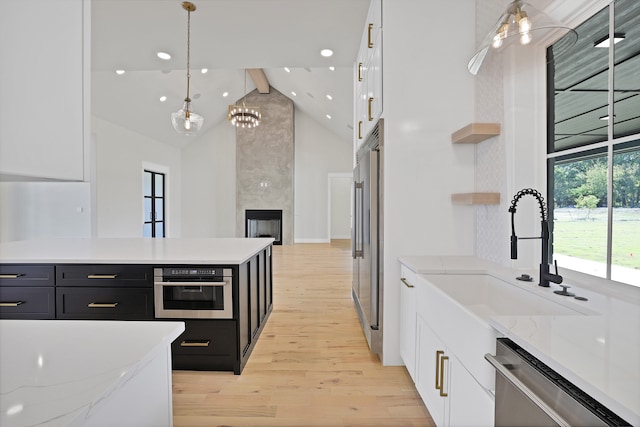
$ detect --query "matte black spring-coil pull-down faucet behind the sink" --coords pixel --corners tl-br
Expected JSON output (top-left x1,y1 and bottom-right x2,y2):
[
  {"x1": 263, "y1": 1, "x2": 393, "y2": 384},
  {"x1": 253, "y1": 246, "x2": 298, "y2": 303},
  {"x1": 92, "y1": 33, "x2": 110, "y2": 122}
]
[{"x1": 509, "y1": 188, "x2": 562, "y2": 288}]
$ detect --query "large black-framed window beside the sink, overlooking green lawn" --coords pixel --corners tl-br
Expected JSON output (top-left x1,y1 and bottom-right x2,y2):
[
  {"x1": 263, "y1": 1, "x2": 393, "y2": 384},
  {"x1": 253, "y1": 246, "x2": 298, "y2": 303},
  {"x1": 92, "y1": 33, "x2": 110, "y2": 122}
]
[{"x1": 547, "y1": 0, "x2": 640, "y2": 286}]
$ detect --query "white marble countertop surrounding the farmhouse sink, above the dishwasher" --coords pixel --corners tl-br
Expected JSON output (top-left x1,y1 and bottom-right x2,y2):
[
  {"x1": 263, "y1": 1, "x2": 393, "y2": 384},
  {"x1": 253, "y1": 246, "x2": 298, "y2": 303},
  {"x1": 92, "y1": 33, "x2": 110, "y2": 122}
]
[{"x1": 400, "y1": 256, "x2": 640, "y2": 426}]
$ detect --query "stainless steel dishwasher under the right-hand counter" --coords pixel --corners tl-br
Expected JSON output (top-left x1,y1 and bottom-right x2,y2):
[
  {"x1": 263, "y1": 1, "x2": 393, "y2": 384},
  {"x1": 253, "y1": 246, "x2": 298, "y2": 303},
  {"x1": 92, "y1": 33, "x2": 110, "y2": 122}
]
[{"x1": 485, "y1": 338, "x2": 631, "y2": 427}]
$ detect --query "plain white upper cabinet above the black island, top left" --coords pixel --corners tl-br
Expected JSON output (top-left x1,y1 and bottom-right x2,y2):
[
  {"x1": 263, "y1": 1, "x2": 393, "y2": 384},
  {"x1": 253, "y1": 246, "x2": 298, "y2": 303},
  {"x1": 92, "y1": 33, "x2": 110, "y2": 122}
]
[{"x1": 0, "y1": 0, "x2": 90, "y2": 181}]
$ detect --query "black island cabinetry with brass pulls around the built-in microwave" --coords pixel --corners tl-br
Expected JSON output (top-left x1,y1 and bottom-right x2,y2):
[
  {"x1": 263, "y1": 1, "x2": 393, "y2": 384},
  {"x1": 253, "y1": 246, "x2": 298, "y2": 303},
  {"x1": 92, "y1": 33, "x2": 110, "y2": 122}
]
[{"x1": 0, "y1": 239, "x2": 273, "y2": 374}]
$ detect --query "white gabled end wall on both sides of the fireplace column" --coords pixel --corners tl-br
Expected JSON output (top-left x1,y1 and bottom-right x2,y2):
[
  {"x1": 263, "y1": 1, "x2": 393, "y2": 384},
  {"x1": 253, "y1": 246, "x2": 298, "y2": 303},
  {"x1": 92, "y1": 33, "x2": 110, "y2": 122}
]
[{"x1": 182, "y1": 106, "x2": 352, "y2": 242}]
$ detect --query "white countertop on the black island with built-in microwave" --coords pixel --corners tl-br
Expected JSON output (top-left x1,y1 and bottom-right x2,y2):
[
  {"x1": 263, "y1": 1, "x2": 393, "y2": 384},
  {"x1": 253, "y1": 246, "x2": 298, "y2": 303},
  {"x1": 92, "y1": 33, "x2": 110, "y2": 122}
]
[{"x1": 0, "y1": 238, "x2": 274, "y2": 264}]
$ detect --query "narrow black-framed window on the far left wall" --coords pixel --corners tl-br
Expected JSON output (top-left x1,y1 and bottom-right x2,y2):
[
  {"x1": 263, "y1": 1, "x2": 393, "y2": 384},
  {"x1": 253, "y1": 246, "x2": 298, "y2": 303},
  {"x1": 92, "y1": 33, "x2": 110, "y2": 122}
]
[{"x1": 142, "y1": 170, "x2": 166, "y2": 237}]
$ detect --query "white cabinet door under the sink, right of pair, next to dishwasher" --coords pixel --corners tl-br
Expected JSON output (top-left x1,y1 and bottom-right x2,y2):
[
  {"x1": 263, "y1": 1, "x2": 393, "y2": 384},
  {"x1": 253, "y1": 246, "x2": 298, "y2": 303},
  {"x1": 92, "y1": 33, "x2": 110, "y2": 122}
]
[{"x1": 447, "y1": 355, "x2": 494, "y2": 427}]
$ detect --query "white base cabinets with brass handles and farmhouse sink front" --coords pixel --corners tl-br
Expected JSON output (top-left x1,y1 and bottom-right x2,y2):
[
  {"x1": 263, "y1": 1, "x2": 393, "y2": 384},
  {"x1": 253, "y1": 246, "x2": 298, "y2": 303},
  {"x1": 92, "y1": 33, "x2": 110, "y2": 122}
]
[{"x1": 400, "y1": 265, "x2": 494, "y2": 427}]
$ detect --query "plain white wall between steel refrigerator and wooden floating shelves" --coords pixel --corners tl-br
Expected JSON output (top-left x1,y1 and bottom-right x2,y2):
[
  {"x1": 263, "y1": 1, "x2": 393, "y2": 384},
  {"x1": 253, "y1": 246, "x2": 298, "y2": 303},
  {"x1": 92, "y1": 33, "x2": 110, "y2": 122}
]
[{"x1": 382, "y1": 0, "x2": 475, "y2": 365}]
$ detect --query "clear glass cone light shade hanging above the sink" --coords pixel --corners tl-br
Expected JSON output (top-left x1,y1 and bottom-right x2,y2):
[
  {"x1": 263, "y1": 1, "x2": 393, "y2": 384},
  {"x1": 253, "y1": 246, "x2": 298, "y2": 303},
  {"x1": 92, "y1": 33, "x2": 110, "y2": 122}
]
[{"x1": 467, "y1": 0, "x2": 578, "y2": 75}]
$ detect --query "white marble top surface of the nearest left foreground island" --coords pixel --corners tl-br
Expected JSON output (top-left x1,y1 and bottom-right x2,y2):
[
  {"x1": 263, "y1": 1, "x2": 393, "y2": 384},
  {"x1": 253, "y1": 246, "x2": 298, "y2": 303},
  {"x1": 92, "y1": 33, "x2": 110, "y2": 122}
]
[{"x1": 0, "y1": 320, "x2": 184, "y2": 427}]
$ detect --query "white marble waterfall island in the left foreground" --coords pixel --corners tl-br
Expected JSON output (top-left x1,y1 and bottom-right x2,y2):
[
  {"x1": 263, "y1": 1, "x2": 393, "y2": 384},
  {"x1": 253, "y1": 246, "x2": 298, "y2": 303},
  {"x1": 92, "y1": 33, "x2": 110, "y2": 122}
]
[{"x1": 0, "y1": 320, "x2": 184, "y2": 427}]
